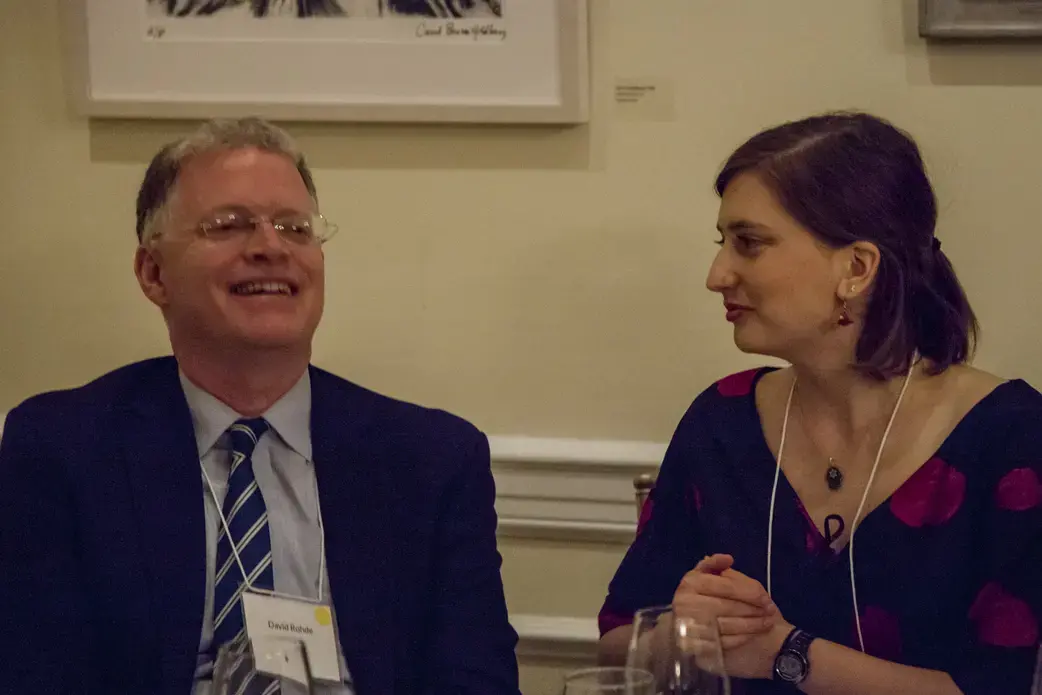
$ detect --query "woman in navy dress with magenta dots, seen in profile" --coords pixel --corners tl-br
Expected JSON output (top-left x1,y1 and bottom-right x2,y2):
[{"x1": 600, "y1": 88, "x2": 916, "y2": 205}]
[{"x1": 600, "y1": 114, "x2": 1042, "y2": 695}]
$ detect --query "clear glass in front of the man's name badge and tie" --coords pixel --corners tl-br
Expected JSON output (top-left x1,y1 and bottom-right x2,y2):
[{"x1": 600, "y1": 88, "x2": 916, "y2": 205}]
[{"x1": 212, "y1": 635, "x2": 314, "y2": 695}]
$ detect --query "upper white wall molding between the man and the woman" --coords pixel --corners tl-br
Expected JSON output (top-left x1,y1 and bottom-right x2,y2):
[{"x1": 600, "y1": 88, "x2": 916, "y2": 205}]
[{"x1": 489, "y1": 436, "x2": 666, "y2": 543}]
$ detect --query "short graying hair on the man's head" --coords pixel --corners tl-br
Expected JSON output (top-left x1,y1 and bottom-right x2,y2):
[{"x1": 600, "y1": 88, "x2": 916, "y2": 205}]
[{"x1": 137, "y1": 117, "x2": 318, "y2": 245}]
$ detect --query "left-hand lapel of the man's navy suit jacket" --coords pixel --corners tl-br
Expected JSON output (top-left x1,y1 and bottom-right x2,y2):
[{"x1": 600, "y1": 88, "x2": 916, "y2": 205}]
[{"x1": 124, "y1": 359, "x2": 206, "y2": 692}]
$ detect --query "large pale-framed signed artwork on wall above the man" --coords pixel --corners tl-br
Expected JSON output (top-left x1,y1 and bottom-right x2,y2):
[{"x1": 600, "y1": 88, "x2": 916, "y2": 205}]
[{"x1": 61, "y1": 0, "x2": 589, "y2": 124}]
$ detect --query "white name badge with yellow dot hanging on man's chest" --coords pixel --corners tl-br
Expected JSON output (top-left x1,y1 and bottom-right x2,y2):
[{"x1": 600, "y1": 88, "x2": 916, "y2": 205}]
[{"x1": 243, "y1": 591, "x2": 342, "y2": 682}]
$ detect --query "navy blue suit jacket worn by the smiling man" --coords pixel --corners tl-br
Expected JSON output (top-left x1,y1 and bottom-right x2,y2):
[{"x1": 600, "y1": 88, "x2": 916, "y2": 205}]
[{"x1": 0, "y1": 357, "x2": 518, "y2": 695}]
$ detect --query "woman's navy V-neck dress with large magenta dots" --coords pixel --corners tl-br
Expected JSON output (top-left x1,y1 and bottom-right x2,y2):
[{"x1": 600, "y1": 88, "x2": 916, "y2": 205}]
[{"x1": 599, "y1": 368, "x2": 1042, "y2": 695}]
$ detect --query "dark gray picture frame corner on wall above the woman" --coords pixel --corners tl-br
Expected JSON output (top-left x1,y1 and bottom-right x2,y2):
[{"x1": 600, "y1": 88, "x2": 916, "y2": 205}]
[{"x1": 919, "y1": 0, "x2": 1042, "y2": 40}]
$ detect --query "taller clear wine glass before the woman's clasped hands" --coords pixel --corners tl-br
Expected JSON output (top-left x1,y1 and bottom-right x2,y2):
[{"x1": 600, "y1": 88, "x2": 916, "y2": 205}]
[{"x1": 626, "y1": 605, "x2": 730, "y2": 695}]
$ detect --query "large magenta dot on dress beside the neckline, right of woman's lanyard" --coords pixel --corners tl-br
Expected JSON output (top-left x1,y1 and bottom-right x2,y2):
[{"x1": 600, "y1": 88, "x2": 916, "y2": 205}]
[{"x1": 890, "y1": 457, "x2": 966, "y2": 528}]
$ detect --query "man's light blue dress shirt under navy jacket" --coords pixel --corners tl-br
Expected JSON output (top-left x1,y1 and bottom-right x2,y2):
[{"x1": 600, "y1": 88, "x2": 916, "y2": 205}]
[{"x1": 180, "y1": 371, "x2": 353, "y2": 695}]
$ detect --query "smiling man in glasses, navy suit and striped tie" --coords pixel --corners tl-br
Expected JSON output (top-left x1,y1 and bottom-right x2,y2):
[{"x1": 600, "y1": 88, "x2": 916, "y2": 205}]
[{"x1": 0, "y1": 119, "x2": 518, "y2": 695}]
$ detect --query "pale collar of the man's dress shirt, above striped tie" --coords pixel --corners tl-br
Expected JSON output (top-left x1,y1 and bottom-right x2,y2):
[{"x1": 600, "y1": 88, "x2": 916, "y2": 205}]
[{"x1": 178, "y1": 370, "x2": 312, "y2": 462}]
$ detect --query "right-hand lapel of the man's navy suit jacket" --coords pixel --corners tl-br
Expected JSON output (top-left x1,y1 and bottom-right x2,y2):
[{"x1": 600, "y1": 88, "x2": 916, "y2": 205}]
[{"x1": 312, "y1": 369, "x2": 395, "y2": 695}]
